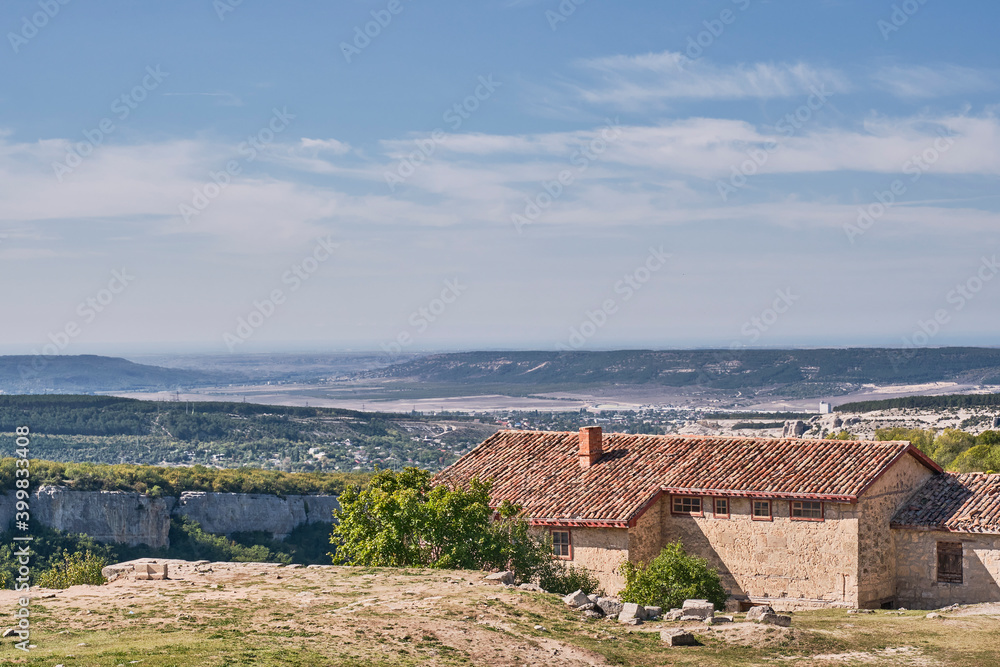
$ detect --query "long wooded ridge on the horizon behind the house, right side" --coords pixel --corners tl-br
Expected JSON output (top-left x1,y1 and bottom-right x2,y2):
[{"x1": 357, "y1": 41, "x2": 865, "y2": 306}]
[{"x1": 360, "y1": 347, "x2": 1000, "y2": 390}]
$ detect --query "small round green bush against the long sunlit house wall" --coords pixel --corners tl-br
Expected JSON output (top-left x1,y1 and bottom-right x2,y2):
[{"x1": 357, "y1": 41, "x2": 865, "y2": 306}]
[{"x1": 619, "y1": 541, "x2": 729, "y2": 610}]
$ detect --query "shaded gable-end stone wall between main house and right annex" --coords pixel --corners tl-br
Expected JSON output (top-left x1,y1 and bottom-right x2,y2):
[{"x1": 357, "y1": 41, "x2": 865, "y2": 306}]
[{"x1": 857, "y1": 455, "x2": 934, "y2": 608}]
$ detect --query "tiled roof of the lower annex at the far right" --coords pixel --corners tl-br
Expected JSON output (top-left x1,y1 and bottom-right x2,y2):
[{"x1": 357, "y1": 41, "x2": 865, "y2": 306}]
[{"x1": 892, "y1": 472, "x2": 1000, "y2": 533}]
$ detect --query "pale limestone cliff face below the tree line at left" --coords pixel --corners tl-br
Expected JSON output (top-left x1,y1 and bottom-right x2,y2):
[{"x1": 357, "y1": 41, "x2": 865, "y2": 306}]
[{"x1": 0, "y1": 486, "x2": 339, "y2": 548}]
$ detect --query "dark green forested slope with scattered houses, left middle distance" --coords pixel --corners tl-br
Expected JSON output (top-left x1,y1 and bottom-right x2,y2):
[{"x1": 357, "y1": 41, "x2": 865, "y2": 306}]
[{"x1": 0, "y1": 395, "x2": 496, "y2": 472}]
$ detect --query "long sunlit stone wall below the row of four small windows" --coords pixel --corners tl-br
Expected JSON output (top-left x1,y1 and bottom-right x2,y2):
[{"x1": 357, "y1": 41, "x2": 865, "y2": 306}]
[{"x1": 660, "y1": 496, "x2": 858, "y2": 609}]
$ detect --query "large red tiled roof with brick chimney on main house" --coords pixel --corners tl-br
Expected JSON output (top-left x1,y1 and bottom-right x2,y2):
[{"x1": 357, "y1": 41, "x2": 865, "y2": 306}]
[{"x1": 435, "y1": 431, "x2": 940, "y2": 526}]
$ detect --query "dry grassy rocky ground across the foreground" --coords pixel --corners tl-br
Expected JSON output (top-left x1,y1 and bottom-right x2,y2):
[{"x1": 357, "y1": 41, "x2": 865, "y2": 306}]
[{"x1": 0, "y1": 561, "x2": 1000, "y2": 667}]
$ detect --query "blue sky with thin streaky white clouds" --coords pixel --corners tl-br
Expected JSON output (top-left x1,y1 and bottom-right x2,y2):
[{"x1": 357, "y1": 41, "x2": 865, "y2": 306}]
[{"x1": 0, "y1": 0, "x2": 1000, "y2": 354}]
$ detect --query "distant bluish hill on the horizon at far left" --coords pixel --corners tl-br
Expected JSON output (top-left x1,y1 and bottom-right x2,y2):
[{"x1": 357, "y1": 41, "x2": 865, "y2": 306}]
[{"x1": 0, "y1": 354, "x2": 222, "y2": 394}]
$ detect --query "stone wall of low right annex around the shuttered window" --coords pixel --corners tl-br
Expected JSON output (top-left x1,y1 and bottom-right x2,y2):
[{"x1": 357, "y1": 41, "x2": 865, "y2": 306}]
[{"x1": 892, "y1": 528, "x2": 1000, "y2": 609}]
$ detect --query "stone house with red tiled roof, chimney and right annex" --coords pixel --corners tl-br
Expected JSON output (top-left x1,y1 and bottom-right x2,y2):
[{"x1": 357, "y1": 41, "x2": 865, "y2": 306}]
[{"x1": 435, "y1": 427, "x2": 1000, "y2": 609}]
